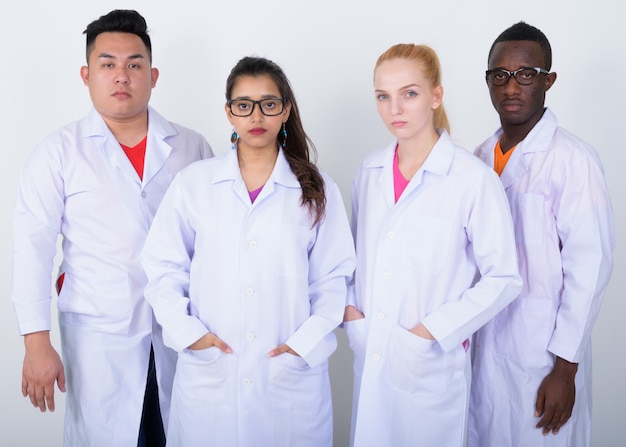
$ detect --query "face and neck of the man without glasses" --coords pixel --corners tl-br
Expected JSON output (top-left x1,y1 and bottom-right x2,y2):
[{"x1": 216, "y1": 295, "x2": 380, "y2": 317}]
[{"x1": 80, "y1": 32, "x2": 159, "y2": 147}]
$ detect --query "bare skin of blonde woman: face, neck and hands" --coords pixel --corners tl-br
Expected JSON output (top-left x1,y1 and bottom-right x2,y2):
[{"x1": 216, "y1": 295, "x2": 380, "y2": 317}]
[{"x1": 344, "y1": 59, "x2": 443, "y2": 340}]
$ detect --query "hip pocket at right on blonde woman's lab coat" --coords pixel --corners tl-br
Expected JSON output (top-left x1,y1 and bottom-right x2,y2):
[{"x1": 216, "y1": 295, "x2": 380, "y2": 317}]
[{"x1": 386, "y1": 326, "x2": 447, "y2": 395}]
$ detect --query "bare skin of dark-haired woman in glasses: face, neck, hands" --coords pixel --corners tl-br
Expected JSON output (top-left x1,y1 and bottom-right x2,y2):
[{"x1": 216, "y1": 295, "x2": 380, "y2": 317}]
[{"x1": 189, "y1": 75, "x2": 298, "y2": 357}]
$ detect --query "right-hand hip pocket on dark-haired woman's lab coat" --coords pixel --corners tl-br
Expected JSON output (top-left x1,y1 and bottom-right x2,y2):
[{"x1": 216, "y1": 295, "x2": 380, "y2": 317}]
[{"x1": 268, "y1": 353, "x2": 326, "y2": 412}]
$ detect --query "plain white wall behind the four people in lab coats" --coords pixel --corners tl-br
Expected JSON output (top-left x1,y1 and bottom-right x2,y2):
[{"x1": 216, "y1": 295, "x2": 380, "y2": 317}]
[{"x1": 0, "y1": 0, "x2": 626, "y2": 447}]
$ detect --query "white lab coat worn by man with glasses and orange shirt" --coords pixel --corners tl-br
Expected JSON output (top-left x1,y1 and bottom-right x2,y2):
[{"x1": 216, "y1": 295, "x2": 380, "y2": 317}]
[{"x1": 470, "y1": 109, "x2": 615, "y2": 447}]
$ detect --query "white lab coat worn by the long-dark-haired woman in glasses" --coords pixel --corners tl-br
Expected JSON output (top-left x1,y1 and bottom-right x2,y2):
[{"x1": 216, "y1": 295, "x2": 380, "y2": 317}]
[{"x1": 142, "y1": 150, "x2": 355, "y2": 447}]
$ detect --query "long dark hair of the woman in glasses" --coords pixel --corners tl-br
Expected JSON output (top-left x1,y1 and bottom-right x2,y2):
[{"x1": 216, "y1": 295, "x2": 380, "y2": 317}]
[{"x1": 226, "y1": 57, "x2": 326, "y2": 226}]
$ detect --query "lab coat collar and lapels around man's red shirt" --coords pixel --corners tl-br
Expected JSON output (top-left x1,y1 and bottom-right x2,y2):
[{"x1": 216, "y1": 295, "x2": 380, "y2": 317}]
[{"x1": 85, "y1": 107, "x2": 178, "y2": 186}]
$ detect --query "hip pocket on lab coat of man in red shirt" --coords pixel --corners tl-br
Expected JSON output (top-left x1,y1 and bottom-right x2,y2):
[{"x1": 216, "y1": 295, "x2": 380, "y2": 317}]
[{"x1": 58, "y1": 272, "x2": 134, "y2": 333}]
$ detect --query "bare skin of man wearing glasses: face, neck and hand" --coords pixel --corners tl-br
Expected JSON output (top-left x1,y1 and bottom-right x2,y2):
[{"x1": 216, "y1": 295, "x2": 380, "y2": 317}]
[{"x1": 487, "y1": 40, "x2": 578, "y2": 435}]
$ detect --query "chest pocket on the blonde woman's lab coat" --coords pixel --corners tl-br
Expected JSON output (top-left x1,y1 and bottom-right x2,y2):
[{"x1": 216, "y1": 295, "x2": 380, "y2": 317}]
[{"x1": 400, "y1": 216, "x2": 454, "y2": 274}]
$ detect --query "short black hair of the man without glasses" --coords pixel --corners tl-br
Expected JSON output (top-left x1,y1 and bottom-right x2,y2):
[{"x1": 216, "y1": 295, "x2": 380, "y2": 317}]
[{"x1": 83, "y1": 9, "x2": 152, "y2": 63}]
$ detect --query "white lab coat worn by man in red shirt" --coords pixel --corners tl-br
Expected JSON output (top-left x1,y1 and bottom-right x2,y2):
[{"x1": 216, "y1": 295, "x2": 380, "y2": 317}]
[{"x1": 12, "y1": 108, "x2": 212, "y2": 447}]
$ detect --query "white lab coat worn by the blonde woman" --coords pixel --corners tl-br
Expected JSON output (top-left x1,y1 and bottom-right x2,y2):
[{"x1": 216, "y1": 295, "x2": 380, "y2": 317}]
[{"x1": 344, "y1": 131, "x2": 521, "y2": 447}]
